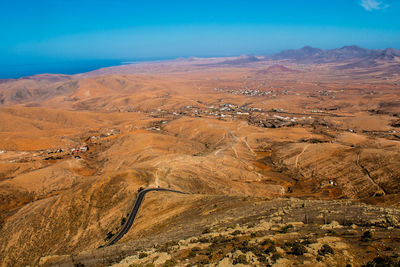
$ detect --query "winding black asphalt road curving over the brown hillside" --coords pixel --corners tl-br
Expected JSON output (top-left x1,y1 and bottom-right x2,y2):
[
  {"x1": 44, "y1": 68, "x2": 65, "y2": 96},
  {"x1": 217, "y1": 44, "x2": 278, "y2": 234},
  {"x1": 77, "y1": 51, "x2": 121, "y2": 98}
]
[{"x1": 105, "y1": 188, "x2": 189, "y2": 247}]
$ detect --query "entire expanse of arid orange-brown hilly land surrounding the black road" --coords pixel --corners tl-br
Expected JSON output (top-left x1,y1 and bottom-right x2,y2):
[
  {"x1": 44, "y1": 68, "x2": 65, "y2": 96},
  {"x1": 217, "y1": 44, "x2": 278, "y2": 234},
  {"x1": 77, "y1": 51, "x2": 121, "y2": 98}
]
[{"x1": 0, "y1": 51, "x2": 400, "y2": 266}]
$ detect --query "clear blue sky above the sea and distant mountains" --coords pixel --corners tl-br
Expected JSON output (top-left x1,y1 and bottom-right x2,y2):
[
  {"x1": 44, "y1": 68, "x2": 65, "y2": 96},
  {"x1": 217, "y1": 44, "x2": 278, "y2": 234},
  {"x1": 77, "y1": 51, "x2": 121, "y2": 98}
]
[{"x1": 0, "y1": 0, "x2": 400, "y2": 64}]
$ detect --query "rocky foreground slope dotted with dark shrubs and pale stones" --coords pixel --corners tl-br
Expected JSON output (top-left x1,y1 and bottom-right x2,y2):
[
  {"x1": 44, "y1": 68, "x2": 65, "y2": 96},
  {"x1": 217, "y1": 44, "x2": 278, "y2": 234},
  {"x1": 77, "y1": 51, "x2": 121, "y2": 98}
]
[{"x1": 40, "y1": 197, "x2": 400, "y2": 267}]
